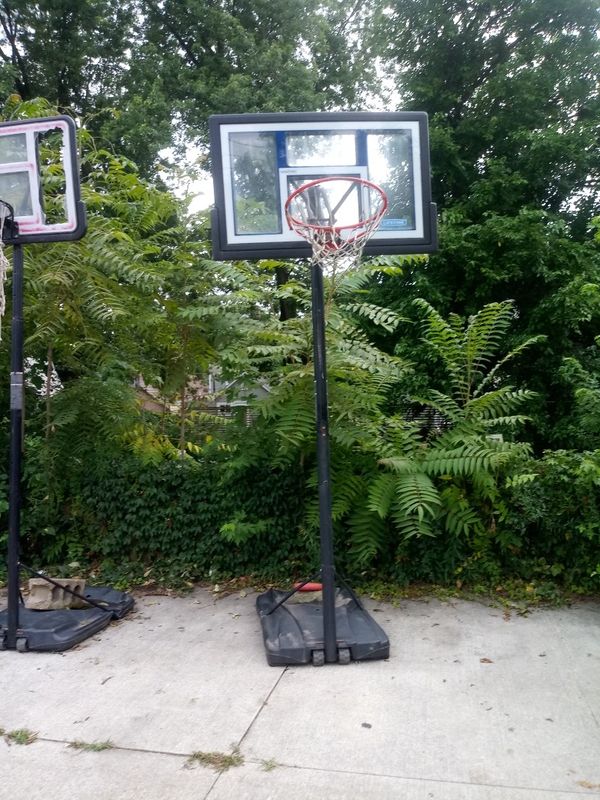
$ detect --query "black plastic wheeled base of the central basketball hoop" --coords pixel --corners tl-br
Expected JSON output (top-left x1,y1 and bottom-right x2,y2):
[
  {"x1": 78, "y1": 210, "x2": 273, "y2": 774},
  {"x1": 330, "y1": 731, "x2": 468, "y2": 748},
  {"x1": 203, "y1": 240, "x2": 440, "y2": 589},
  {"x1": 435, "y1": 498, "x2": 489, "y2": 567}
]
[{"x1": 256, "y1": 589, "x2": 390, "y2": 667}]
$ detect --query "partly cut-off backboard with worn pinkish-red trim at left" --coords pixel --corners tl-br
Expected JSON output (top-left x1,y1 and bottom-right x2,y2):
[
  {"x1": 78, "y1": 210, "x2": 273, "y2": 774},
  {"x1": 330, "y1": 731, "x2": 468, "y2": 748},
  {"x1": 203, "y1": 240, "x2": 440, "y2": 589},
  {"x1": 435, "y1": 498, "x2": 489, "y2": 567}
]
[{"x1": 0, "y1": 116, "x2": 86, "y2": 244}]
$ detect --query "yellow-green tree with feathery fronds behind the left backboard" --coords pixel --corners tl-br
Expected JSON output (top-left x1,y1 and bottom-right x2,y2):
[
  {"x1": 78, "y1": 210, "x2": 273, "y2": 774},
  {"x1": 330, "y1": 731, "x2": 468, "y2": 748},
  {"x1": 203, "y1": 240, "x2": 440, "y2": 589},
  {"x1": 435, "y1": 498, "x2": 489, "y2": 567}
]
[{"x1": 0, "y1": 101, "x2": 211, "y2": 552}]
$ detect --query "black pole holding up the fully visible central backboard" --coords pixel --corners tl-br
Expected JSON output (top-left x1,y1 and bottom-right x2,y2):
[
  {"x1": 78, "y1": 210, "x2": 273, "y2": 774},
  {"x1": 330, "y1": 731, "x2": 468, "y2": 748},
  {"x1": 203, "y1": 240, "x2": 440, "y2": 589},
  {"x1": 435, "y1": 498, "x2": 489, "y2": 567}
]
[{"x1": 311, "y1": 263, "x2": 338, "y2": 663}]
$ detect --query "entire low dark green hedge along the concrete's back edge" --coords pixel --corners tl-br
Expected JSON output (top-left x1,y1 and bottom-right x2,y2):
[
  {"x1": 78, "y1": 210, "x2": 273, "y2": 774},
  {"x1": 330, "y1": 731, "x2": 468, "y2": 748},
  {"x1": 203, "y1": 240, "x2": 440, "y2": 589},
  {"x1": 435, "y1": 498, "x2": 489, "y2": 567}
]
[{"x1": 3, "y1": 438, "x2": 600, "y2": 596}]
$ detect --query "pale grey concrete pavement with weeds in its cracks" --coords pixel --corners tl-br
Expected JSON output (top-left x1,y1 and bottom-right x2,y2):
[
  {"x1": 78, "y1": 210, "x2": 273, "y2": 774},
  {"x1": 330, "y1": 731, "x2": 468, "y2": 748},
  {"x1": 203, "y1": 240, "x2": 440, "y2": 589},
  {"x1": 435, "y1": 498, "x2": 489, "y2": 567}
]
[{"x1": 0, "y1": 590, "x2": 600, "y2": 800}]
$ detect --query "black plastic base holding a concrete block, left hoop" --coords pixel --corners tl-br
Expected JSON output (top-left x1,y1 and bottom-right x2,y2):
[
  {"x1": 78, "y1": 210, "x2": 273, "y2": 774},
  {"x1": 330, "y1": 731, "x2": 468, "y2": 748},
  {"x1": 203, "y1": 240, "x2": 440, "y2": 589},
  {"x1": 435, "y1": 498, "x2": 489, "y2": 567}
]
[{"x1": 0, "y1": 586, "x2": 134, "y2": 652}]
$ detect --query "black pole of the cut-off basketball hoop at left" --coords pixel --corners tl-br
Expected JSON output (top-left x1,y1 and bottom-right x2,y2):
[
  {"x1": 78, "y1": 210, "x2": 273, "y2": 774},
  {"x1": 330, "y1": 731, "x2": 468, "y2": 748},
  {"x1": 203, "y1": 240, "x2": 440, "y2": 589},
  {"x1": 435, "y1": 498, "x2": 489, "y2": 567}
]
[{"x1": 5, "y1": 244, "x2": 24, "y2": 649}]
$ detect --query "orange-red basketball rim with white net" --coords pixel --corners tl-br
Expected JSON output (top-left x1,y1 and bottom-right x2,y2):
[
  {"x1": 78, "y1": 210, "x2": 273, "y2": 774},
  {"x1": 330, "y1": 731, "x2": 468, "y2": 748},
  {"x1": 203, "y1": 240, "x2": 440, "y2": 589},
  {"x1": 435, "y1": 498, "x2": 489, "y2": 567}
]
[{"x1": 285, "y1": 175, "x2": 388, "y2": 271}]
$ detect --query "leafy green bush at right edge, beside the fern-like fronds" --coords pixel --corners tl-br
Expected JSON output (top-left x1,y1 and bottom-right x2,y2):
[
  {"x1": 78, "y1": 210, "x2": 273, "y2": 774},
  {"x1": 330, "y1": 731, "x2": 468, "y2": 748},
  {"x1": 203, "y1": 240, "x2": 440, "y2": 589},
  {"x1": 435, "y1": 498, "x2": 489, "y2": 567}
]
[{"x1": 350, "y1": 450, "x2": 600, "y2": 599}]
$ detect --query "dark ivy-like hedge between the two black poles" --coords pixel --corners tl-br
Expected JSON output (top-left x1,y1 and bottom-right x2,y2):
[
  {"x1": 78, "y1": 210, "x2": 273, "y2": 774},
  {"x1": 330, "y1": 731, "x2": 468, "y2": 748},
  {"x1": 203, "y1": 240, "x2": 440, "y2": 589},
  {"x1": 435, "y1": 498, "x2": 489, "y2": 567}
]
[{"x1": 8, "y1": 438, "x2": 307, "y2": 578}]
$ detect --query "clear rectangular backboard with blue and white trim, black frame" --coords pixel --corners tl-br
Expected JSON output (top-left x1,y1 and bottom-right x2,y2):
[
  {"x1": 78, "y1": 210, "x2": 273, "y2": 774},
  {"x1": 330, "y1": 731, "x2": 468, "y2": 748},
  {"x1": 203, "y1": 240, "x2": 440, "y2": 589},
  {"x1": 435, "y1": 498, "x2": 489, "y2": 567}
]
[{"x1": 209, "y1": 112, "x2": 437, "y2": 260}]
